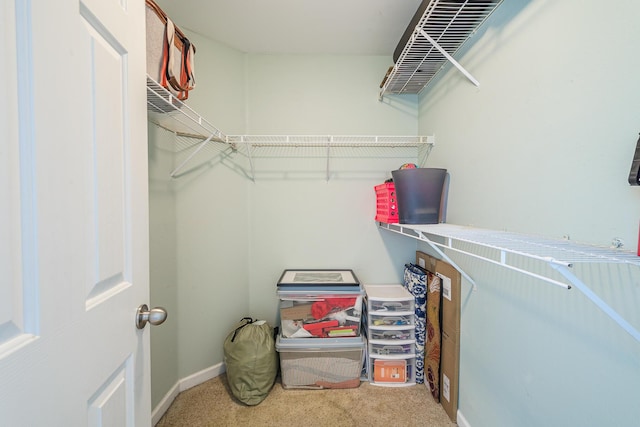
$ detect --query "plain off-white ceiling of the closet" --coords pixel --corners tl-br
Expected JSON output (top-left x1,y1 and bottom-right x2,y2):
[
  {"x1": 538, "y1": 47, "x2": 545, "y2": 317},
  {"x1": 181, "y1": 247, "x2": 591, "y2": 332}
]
[{"x1": 156, "y1": 0, "x2": 421, "y2": 56}]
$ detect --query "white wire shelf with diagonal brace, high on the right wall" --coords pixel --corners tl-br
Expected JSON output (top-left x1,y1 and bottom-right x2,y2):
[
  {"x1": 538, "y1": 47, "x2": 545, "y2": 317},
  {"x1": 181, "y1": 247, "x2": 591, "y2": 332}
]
[{"x1": 379, "y1": 0, "x2": 502, "y2": 99}]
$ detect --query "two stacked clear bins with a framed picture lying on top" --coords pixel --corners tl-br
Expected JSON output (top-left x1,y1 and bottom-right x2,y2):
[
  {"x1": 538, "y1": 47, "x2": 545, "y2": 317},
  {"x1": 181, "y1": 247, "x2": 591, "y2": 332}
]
[{"x1": 276, "y1": 270, "x2": 365, "y2": 389}]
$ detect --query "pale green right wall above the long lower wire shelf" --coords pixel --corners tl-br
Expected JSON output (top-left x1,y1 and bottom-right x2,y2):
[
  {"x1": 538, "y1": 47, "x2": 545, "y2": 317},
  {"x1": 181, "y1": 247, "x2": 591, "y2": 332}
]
[{"x1": 420, "y1": 0, "x2": 640, "y2": 249}]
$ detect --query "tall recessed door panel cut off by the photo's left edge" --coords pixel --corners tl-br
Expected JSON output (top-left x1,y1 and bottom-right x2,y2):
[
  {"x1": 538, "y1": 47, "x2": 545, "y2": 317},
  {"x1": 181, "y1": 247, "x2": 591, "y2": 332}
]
[{"x1": 0, "y1": 2, "x2": 37, "y2": 357}]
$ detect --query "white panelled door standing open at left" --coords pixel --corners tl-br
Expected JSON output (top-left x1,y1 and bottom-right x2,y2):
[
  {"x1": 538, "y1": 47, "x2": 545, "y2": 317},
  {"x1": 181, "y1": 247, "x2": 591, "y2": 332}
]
[{"x1": 0, "y1": 0, "x2": 151, "y2": 427}]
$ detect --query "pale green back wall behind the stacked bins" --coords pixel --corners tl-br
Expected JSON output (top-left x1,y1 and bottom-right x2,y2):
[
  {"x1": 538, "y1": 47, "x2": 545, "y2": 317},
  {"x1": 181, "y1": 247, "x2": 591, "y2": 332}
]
[{"x1": 247, "y1": 55, "x2": 417, "y2": 324}]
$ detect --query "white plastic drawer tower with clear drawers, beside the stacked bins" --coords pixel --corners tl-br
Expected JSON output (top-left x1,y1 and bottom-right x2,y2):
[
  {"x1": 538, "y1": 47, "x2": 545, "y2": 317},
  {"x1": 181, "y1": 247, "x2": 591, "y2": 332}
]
[{"x1": 364, "y1": 284, "x2": 416, "y2": 387}]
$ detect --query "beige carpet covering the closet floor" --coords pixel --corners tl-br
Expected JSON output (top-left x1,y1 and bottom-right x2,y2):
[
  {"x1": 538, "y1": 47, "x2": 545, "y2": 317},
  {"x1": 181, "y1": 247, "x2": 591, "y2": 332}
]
[{"x1": 156, "y1": 374, "x2": 456, "y2": 427}]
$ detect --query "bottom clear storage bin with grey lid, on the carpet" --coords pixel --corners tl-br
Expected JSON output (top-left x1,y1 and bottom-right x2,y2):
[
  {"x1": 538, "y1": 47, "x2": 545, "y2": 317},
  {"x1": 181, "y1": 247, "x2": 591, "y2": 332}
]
[{"x1": 276, "y1": 337, "x2": 365, "y2": 389}]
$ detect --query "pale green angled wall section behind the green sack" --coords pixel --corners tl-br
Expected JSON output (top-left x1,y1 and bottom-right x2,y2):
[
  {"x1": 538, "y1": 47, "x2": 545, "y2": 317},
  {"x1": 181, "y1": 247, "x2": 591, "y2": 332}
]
[{"x1": 175, "y1": 33, "x2": 249, "y2": 378}]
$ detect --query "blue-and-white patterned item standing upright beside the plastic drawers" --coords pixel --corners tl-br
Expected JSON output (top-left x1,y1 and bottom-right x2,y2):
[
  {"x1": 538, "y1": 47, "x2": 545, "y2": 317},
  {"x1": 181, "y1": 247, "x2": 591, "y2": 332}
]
[{"x1": 403, "y1": 264, "x2": 427, "y2": 384}]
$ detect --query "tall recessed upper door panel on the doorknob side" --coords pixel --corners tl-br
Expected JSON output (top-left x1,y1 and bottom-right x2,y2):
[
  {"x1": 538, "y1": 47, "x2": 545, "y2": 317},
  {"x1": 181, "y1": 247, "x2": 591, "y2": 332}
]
[{"x1": 81, "y1": 3, "x2": 130, "y2": 308}]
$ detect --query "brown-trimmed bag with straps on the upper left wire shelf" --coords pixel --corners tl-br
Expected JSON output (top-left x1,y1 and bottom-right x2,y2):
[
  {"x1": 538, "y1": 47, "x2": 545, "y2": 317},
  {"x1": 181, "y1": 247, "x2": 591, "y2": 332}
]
[{"x1": 146, "y1": 0, "x2": 196, "y2": 101}]
